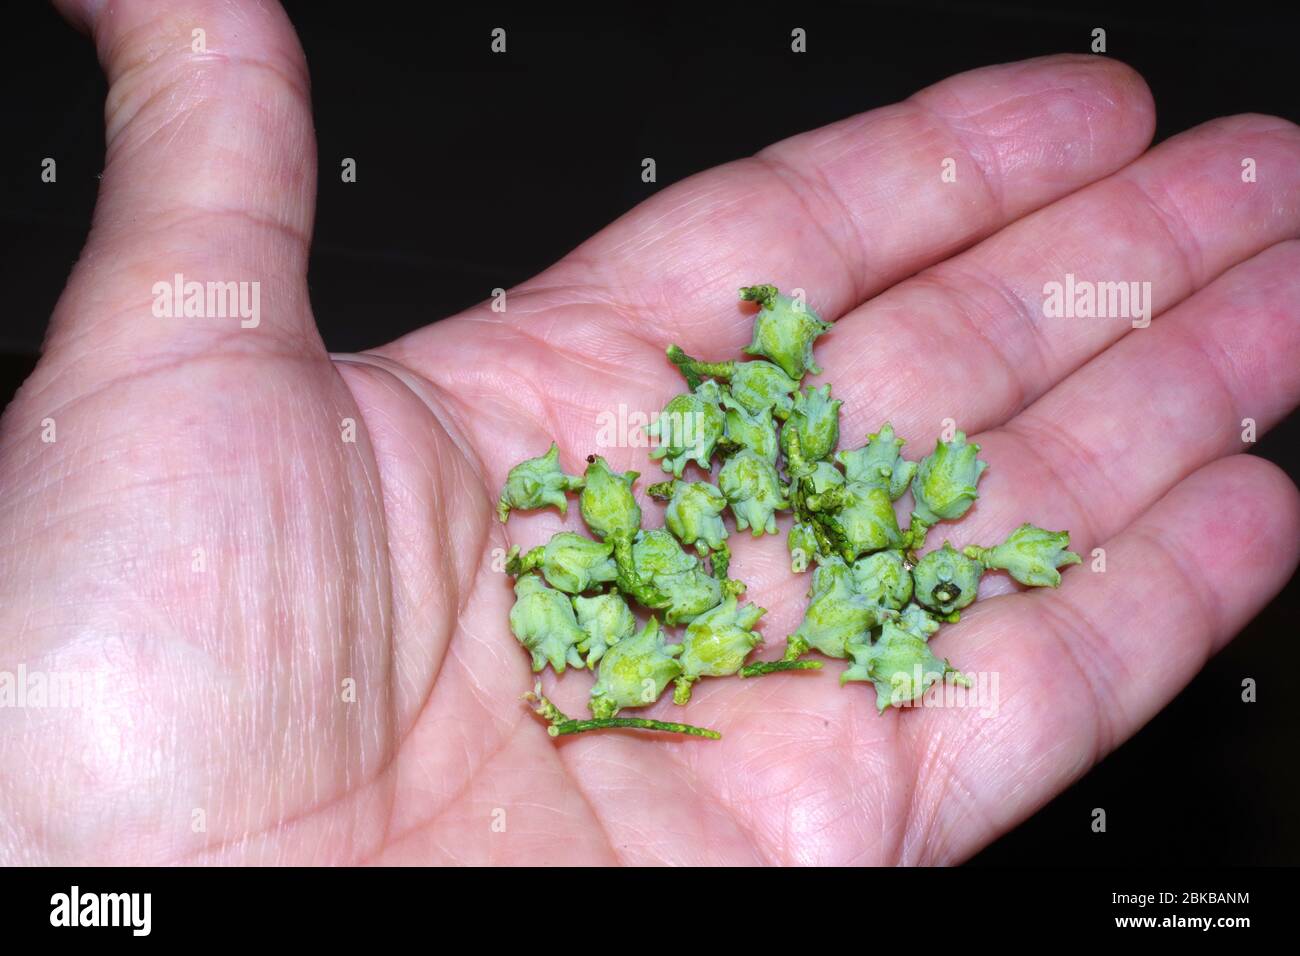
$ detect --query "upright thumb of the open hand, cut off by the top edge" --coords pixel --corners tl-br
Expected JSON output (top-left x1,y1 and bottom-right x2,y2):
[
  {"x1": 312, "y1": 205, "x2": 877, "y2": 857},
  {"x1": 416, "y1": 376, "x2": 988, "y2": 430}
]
[{"x1": 46, "y1": 0, "x2": 324, "y2": 366}]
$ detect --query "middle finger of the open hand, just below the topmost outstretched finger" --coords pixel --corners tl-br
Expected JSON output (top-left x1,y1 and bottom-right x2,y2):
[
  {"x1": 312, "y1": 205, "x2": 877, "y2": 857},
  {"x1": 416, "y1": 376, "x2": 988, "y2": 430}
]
[{"x1": 819, "y1": 116, "x2": 1300, "y2": 445}]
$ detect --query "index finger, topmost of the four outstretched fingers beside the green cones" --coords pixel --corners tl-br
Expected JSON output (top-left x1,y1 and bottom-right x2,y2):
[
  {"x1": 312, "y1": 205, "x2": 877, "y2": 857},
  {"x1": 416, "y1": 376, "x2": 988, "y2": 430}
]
[{"x1": 543, "y1": 55, "x2": 1154, "y2": 352}]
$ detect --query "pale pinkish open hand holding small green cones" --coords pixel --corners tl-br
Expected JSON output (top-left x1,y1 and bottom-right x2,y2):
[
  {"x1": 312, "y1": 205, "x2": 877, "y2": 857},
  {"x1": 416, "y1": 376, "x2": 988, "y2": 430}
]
[{"x1": 0, "y1": 0, "x2": 1300, "y2": 864}]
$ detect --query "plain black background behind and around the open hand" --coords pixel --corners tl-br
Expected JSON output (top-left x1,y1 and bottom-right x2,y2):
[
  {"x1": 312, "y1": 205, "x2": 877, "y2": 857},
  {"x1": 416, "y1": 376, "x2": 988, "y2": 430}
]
[{"x1": 0, "y1": 1, "x2": 1300, "y2": 865}]
